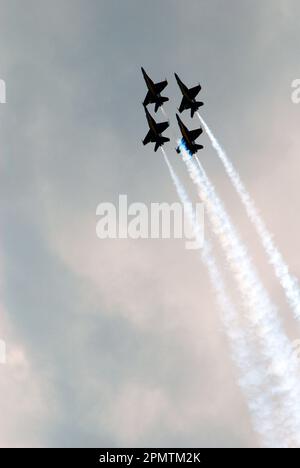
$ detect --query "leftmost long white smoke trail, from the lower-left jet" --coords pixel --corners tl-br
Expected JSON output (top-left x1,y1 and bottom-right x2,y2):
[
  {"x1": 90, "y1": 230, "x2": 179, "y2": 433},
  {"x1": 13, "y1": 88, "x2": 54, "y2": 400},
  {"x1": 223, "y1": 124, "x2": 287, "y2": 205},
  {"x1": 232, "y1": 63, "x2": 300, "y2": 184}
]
[{"x1": 161, "y1": 148, "x2": 285, "y2": 447}]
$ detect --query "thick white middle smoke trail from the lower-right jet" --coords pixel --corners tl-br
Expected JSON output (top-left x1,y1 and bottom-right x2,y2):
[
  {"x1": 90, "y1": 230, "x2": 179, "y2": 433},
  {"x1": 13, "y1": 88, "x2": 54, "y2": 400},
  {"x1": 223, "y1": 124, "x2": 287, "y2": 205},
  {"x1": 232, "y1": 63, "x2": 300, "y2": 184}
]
[{"x1": 181, "y1": 145, "x2": 300, "y2": 446}]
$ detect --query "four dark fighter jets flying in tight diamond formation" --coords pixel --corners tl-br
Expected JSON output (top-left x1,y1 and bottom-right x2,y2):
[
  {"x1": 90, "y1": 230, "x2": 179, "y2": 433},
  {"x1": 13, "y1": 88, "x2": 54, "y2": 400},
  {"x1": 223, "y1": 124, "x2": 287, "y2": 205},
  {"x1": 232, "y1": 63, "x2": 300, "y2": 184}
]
[{"x1": 142, "y1": 68, "x2": 203, "y2": 155}]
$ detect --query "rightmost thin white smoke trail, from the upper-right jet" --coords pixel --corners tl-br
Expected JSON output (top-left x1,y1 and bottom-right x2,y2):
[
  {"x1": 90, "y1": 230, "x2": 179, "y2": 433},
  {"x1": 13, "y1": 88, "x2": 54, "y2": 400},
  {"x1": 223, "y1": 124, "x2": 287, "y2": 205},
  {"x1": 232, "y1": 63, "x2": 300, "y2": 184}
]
[{"x1": 197, "y1": 112, "x2": 300, "y2": 320}]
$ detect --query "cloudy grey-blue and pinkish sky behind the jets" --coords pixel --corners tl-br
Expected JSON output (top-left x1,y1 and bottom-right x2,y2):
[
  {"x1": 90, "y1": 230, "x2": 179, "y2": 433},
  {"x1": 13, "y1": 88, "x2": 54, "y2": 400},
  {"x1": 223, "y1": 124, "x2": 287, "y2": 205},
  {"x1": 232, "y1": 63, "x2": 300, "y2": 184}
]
[{"x1": 0, "y1": 0, "x2": 300, "y2": 447}]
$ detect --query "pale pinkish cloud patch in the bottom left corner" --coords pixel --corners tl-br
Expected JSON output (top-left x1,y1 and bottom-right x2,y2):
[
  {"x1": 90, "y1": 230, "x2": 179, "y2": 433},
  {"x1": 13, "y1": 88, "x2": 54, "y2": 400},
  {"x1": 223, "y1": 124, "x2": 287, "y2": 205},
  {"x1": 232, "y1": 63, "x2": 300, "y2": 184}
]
[{"x1": 0, "y1": 300, "x2": 56, "y2": 447}]
